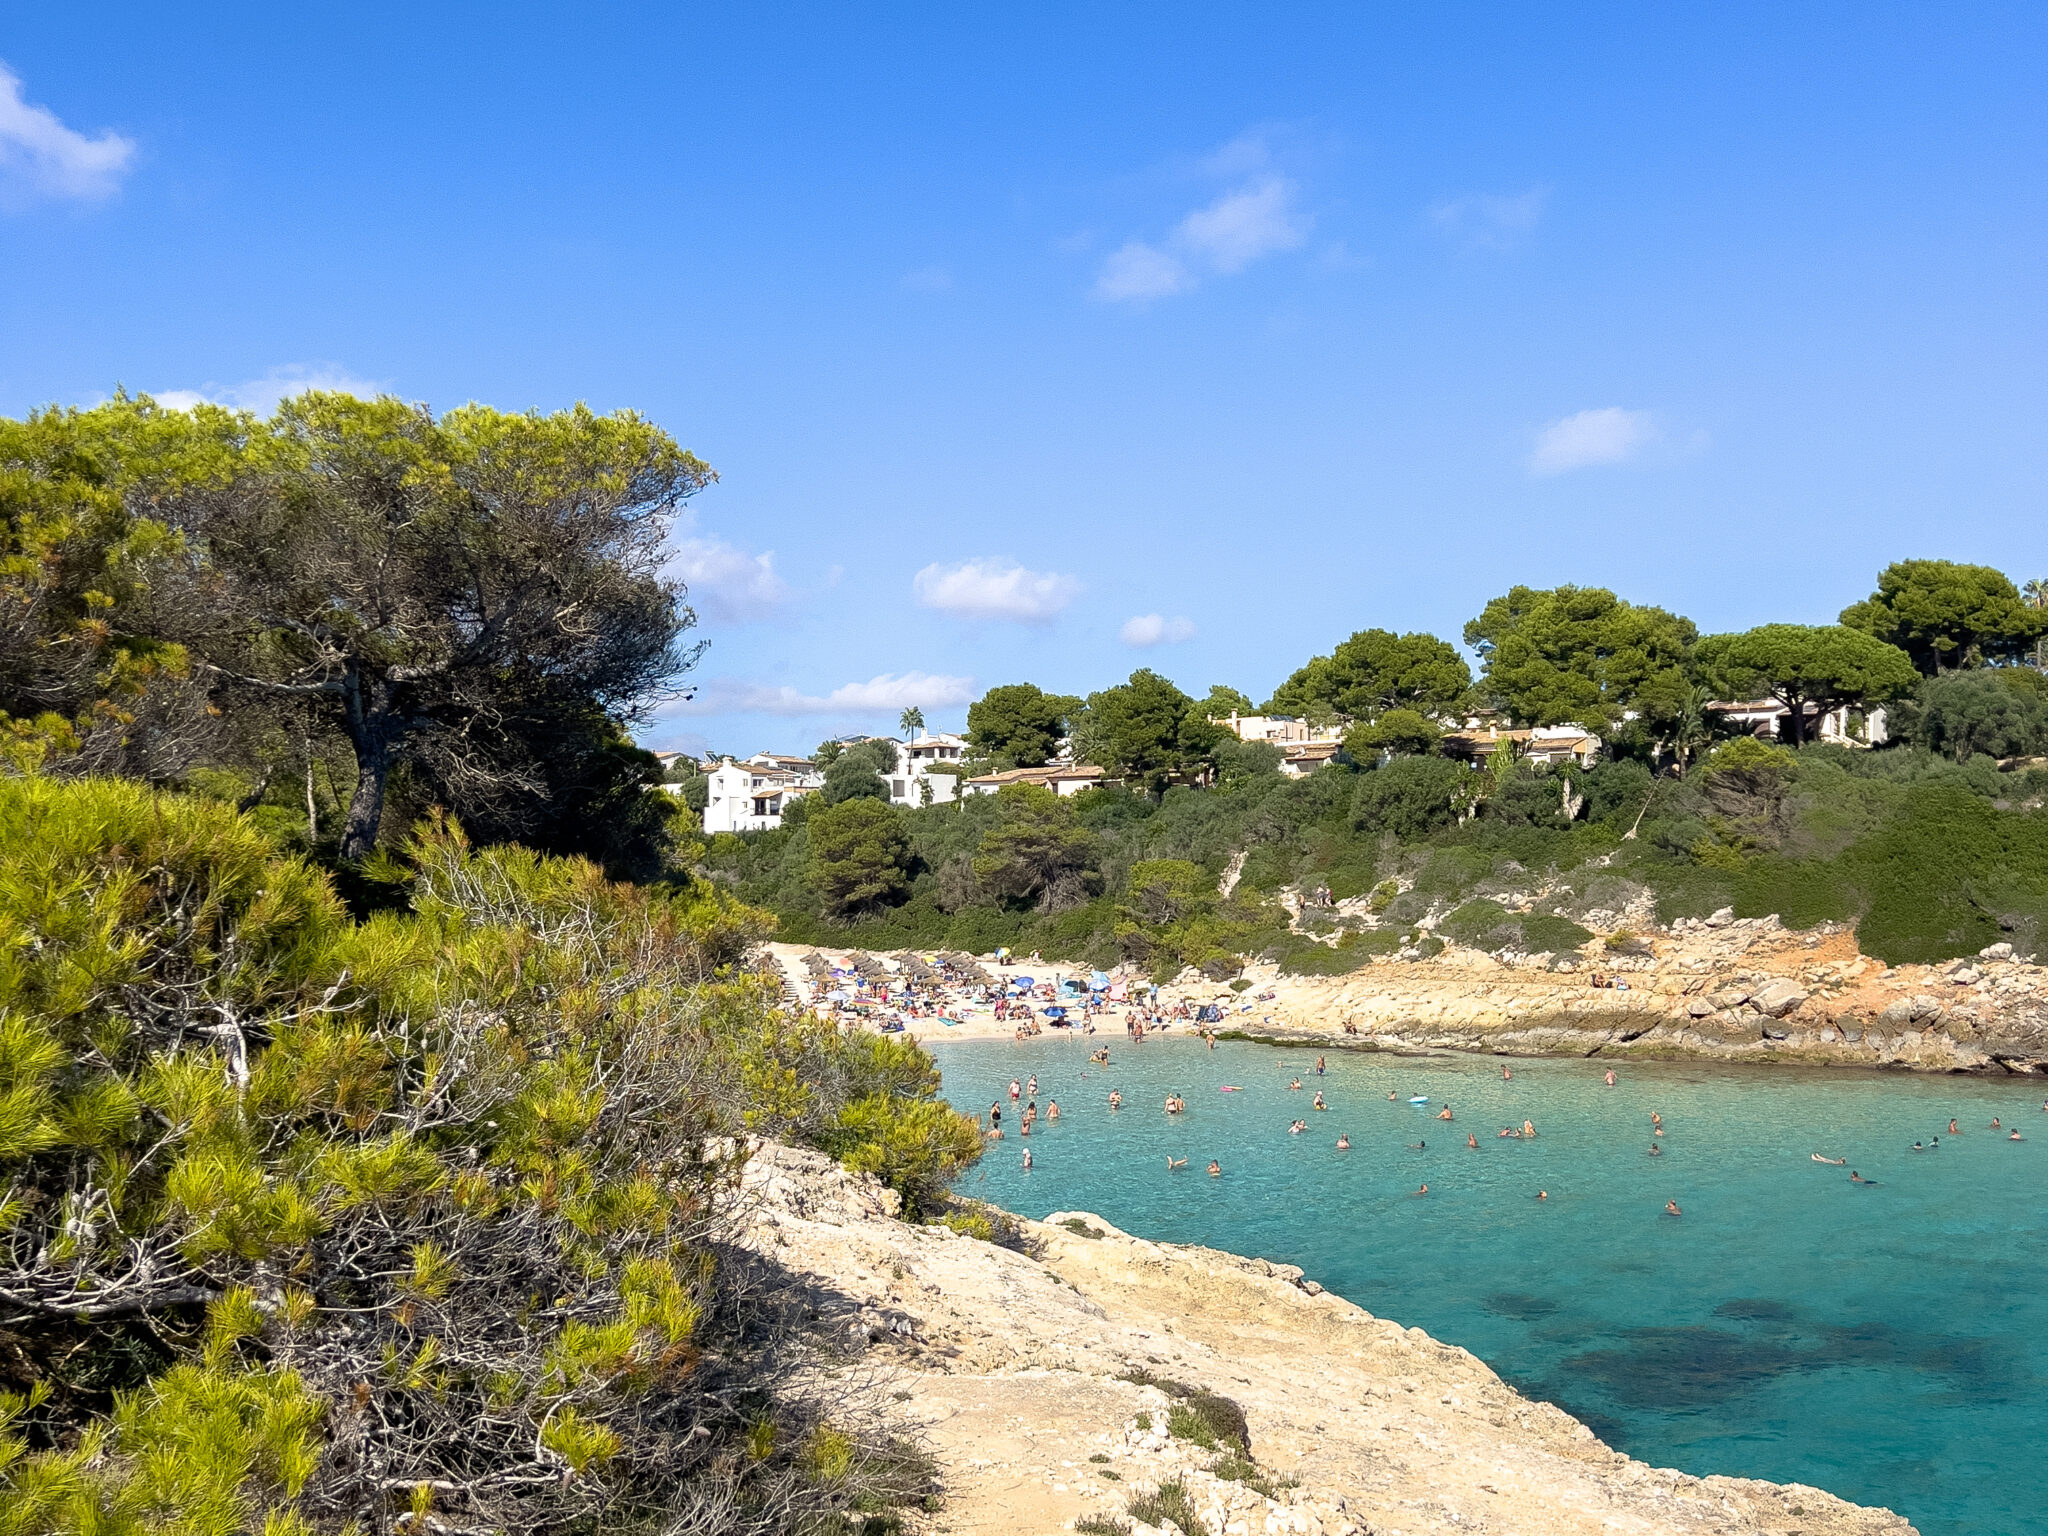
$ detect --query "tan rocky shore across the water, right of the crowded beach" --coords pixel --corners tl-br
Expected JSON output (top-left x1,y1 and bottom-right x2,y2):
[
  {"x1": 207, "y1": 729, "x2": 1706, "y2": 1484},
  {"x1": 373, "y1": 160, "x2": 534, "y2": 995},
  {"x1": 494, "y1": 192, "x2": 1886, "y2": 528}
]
[{"x1": 1235, "y1": 913, "x2": 2048, "y2": 1075}]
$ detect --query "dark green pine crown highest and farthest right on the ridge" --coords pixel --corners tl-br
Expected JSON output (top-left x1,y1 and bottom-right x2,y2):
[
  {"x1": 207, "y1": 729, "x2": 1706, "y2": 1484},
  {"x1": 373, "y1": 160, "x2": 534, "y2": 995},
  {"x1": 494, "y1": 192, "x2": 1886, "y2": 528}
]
[{"x1": 1841, "y1": 559, "x2": 2048, "y2": 678}]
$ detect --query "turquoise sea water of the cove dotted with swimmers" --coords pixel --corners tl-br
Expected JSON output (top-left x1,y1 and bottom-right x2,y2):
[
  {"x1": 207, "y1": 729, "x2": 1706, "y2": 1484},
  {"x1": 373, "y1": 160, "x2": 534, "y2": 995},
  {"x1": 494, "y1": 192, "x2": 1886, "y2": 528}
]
[{"x1": 936, "y1": 1034, "x2": 2048, "y2": 1536}]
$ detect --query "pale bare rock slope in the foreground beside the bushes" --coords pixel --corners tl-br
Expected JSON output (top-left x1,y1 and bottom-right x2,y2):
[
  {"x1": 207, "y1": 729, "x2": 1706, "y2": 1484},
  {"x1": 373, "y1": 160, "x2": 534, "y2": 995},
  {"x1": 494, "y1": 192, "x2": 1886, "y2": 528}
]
[{"x1": 739, "y1": 1145, "x2": 1913, "y2": 1536}]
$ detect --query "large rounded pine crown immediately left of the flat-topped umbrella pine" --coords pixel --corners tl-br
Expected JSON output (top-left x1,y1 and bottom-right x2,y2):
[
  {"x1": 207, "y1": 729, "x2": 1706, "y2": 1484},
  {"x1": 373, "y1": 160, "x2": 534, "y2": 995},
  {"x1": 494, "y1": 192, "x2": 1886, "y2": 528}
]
[{"x1": 1464, "y1": 586, "x2": 1700, "y2": 731}]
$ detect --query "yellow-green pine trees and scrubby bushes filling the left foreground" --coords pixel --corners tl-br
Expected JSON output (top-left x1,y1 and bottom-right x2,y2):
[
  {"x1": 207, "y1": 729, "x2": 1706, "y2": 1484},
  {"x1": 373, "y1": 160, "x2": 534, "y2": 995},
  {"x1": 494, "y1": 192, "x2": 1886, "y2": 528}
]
[{"x1": 0, "y1": 395, "x2": 979, "y2": 1536}]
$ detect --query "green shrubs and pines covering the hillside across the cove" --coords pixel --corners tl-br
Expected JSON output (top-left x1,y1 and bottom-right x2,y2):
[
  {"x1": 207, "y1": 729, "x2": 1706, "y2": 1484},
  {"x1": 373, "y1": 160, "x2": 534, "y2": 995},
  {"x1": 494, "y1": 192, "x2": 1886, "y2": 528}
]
[{"x1": 702, "y1": 561, "x2": 2048, "y2": 977}]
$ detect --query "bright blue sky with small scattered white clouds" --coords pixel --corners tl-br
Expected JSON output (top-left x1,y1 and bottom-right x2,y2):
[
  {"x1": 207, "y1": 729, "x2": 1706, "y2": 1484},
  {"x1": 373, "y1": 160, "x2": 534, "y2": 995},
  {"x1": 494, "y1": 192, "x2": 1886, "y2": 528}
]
[{"x1": 0, "y1": 4, "x2": 2048, "y2": 752}]
